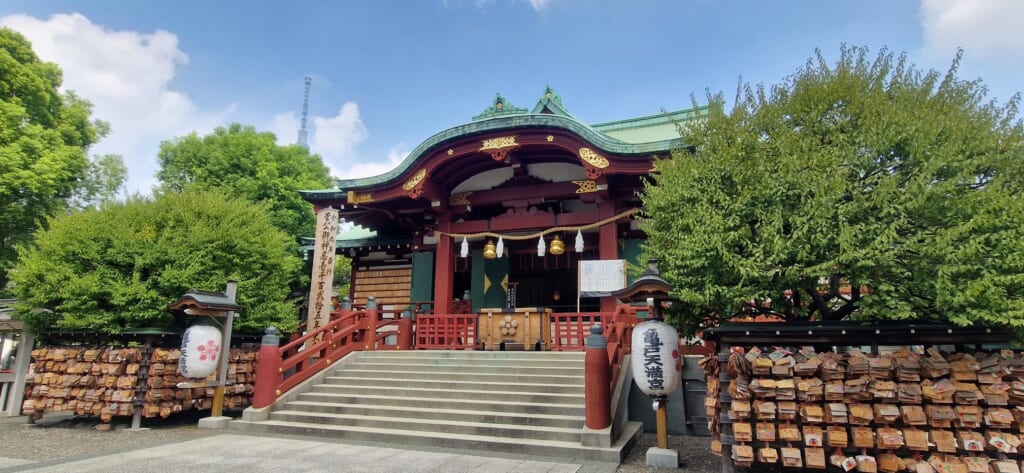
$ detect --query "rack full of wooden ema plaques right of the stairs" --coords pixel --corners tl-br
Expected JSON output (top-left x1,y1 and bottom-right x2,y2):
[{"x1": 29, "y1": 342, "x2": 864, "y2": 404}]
[{"x1": 701, "y1": 324, "x2": 1024, "y2": 473}]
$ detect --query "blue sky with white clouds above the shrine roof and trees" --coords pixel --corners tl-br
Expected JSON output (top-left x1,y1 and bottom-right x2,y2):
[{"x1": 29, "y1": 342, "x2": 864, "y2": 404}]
[{"x1": 0, "y1": 0, "x2": 1024, "y2": 192}]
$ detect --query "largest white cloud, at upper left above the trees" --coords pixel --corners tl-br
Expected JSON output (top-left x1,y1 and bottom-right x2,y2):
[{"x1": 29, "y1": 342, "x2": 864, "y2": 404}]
[{"x1": 0, "y1": 13, "x2": 234, "y2": 194}]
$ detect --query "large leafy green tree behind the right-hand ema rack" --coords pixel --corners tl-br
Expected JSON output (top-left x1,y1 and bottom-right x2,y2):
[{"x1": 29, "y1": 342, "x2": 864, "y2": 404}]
[{"x1": 642, "y1": 47, "x2": 1024, "y2": 333}]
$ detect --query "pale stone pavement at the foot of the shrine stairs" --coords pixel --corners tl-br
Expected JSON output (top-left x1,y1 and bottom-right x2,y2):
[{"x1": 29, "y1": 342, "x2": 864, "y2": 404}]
[{"x1": 0, "y1": 433, "x2": 616, "y2": 473}]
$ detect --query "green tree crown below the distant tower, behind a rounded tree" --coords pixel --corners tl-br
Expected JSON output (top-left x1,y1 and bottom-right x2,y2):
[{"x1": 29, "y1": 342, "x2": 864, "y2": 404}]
[{"x1": 157, "y1": 124, "x2": 332, "y2": 241}]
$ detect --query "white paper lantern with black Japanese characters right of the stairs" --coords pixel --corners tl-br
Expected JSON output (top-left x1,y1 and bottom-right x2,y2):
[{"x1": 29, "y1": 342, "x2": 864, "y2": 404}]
[{"x1": 631, "y1": 320, "x2": 683, "y2": 396}]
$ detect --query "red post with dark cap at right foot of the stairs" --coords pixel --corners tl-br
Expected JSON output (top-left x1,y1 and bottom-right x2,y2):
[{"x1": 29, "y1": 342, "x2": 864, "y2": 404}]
[{"x1": 584, "y1": 323, "x2": 611, "y2": 430}]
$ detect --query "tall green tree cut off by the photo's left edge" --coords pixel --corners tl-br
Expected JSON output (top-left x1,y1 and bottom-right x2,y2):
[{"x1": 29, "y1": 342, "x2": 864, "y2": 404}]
[{"x1": 0, "y1": 28, "x2": 108, "y2": 291}]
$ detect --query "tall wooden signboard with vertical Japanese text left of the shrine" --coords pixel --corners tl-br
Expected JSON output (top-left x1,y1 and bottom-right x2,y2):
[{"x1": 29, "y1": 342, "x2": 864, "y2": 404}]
[{"x1": 306, "y1": 207, "x2": 338, "y2": 339}]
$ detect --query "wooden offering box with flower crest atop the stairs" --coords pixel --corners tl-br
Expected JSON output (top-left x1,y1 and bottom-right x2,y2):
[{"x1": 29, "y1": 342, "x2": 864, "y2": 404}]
[{"x1": 477, "y1": 307, "x2": 551, "y2": 350}]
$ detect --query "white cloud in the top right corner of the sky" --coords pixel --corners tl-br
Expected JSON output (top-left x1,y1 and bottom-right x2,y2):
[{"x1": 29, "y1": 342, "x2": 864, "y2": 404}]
[{"x1": 921, "y1": 0, "x2": 1024, "y2": 61}]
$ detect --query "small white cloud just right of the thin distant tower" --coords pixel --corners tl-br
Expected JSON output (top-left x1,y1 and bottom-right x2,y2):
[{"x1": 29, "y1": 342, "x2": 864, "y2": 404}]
[{"x1": 309, "y1": 101, "x2": 370, "y2": 175}]
